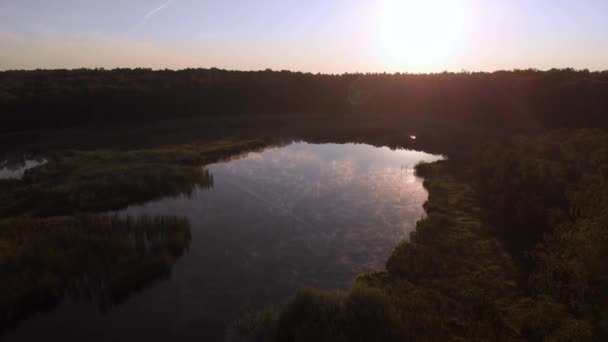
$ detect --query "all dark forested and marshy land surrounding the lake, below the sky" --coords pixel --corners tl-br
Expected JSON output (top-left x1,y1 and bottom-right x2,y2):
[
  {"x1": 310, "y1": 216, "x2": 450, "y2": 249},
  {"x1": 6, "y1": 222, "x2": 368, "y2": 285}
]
[{"x1": 0, "y1": 69, "x2": 608, "y2": 342}]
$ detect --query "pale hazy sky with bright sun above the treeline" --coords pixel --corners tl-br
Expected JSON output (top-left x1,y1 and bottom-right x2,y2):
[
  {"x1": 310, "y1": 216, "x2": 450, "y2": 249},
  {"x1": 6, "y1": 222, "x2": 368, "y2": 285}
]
[{"x1": 0, "y1": 0, "x2": 608, "y2": 73}]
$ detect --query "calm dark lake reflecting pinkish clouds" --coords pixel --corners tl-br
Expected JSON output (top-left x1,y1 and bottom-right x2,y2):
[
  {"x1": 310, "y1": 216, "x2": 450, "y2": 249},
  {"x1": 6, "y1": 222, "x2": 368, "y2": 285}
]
[{"x1": 5, "y1": 143, "x2": 440, "y2": 341}]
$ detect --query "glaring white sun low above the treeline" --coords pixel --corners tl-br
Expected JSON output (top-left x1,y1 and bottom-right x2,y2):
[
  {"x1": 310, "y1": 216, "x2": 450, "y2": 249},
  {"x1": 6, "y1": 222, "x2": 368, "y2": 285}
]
[{"x1": 376, "y1": 0, "x2": 468, "y2": 72}]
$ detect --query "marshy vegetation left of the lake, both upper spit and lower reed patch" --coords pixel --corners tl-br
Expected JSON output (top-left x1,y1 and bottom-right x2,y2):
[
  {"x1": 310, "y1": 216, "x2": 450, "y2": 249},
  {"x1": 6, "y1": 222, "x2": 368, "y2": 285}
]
[{"x1": 0, "y1": 140, "x2": 266, "y2": 332}]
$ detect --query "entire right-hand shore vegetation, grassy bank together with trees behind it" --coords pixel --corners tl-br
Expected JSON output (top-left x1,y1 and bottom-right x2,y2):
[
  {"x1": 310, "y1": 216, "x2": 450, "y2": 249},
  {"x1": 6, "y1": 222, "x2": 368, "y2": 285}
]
[{"x1": 236, "y1": 130, "x2": 608, "y2": 341}]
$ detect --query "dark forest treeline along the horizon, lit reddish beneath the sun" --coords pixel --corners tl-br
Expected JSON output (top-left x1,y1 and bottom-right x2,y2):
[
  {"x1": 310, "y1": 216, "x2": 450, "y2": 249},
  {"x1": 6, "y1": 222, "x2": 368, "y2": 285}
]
[{"x1": 0, "y1": 69, "x2": 608, "y2": 132}]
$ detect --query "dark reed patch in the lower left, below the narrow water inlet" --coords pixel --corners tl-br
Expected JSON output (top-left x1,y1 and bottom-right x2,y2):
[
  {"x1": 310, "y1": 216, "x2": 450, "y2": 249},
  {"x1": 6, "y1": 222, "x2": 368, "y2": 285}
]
[{"x1": 0, "y1": 215, "x2": 190, "y2": 331}]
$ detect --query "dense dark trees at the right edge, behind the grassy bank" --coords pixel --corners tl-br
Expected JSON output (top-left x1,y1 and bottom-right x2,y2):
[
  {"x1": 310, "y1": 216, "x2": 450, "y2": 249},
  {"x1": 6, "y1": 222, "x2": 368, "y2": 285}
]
[{"x1": 475, "y1": 130, "x2": 608, "y2": 340}]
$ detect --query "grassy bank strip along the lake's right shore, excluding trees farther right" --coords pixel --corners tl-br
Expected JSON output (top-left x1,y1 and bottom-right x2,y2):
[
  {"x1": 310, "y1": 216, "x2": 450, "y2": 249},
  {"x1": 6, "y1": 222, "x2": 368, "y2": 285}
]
[{"x1": 232, "y1": 161, "x2": 519, "y2": 341}]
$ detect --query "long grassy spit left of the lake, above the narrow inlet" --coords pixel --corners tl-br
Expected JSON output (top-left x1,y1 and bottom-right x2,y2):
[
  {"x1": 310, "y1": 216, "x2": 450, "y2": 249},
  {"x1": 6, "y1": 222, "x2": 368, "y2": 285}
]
[{"x1": 0, "y1": 140, "x2": 265, "y2": 217}]
